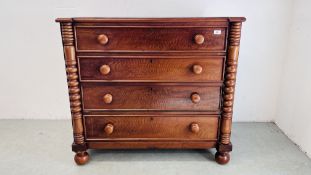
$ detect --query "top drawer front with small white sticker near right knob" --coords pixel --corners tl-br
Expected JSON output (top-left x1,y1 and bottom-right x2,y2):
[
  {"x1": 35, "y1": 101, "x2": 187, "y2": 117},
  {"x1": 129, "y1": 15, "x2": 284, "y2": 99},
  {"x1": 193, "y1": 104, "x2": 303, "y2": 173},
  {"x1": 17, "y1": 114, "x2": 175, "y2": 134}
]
[{"x1": 76, "y1": 26, "x2": 226, "y2": 52}]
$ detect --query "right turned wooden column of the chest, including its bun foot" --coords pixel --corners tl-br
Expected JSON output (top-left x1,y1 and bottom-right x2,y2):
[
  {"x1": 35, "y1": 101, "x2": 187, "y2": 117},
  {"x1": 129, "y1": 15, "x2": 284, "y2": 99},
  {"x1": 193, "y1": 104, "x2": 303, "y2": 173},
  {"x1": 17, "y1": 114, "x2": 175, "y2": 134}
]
[{"x1": 215, "y1": 21, "x2": 242, "y2": 164}]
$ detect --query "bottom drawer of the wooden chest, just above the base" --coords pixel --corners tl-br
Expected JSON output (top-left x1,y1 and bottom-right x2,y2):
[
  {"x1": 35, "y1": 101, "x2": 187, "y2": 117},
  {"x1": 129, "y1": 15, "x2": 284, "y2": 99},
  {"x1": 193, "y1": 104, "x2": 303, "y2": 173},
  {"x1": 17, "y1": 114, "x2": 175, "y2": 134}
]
[{"x1": 85, "y1": 116, "x2": 218, "y2": 140}]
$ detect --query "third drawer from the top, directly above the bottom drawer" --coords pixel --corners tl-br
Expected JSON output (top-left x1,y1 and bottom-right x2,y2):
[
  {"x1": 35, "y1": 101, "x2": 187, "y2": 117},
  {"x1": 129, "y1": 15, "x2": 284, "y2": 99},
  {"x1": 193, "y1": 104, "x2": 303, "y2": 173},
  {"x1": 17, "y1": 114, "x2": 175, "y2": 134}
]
[{"x1": 82, "y1": 83, "x2": 220, "y2": 111}]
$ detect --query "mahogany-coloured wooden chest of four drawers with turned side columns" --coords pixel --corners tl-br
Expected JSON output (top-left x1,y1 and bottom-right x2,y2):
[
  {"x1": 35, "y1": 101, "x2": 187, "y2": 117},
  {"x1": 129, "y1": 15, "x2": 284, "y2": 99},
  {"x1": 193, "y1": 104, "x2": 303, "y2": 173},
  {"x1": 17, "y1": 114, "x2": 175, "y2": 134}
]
[{"x1": 56, "y1": 17, "x2": 245, "y2": 165}]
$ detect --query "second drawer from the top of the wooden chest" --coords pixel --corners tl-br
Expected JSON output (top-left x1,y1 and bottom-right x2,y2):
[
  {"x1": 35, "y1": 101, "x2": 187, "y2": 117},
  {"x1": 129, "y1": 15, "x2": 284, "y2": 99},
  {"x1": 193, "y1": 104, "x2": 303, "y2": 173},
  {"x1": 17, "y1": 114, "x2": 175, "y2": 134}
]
[{"x1": 78, "y1": 56, "x2": 224, "y2": 82}]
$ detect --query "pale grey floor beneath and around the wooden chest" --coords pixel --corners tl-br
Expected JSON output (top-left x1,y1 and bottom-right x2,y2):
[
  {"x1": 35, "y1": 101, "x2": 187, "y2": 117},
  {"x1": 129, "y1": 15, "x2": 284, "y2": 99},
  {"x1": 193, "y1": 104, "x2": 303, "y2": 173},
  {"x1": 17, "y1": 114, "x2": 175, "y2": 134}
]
[{"x1": 0, "y1": 120, "x2": 311, "y2": 175}]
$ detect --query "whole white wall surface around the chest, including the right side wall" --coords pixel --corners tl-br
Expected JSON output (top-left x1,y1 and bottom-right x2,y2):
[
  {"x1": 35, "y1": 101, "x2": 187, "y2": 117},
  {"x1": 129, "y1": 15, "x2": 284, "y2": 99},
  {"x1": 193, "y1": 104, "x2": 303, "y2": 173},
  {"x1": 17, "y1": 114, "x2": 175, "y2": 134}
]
[{"x1": 0, "y1": 0, "x2": 311, "y2": 156}]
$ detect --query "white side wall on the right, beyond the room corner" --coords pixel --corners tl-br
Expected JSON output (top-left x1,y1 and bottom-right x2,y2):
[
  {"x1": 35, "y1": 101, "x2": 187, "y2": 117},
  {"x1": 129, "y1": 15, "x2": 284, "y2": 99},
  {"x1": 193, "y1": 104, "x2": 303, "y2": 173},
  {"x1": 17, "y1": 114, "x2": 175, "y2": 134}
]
[{"x1": 275, "y1": 0, "x2": 311, "y2": 157}]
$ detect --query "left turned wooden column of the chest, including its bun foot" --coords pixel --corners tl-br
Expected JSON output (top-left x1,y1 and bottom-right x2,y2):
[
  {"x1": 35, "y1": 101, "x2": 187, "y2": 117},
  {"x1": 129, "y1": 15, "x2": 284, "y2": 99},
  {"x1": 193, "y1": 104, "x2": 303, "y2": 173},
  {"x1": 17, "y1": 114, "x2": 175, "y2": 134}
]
[{"x1": 58, "y1": 19, "x2": 89, "y2": 165}]
